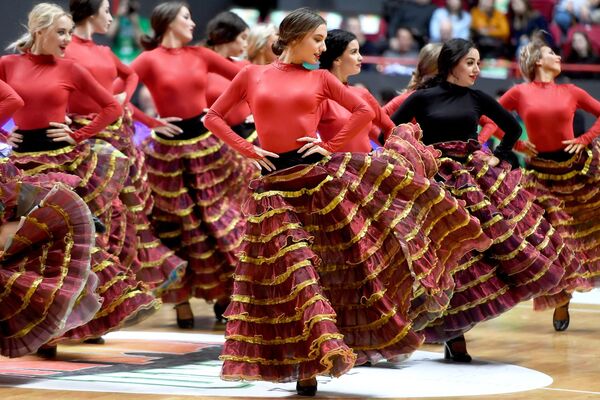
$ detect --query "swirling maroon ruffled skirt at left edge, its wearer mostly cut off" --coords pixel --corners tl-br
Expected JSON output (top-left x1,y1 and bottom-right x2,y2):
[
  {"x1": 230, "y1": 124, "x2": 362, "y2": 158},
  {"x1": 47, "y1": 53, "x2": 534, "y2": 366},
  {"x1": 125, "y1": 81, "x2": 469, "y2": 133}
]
[{"x1": 0, "y1": 169, "x2": 101, "y2": 357}]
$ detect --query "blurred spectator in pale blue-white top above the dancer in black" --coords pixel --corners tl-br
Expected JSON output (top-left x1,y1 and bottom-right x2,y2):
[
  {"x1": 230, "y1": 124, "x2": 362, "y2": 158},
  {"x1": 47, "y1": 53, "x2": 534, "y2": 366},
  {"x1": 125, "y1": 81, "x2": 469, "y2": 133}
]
[{"x1": 429, "y1": 0, "x2": 471, "y2": 42}]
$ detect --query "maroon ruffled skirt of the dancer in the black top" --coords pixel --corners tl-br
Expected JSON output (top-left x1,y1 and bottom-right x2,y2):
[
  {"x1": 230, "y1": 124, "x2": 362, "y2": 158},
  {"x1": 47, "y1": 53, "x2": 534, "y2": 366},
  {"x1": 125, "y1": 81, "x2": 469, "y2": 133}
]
[{"x1": 424, "y1": 141, "x2": 576, "y2": 342}]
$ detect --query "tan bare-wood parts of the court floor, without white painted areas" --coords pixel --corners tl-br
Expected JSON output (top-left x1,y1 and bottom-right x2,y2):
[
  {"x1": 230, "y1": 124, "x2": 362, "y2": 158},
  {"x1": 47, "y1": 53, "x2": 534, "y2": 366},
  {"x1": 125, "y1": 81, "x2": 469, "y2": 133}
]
[{"x1": 0, "y1": 302, "x2": 600, "y2": 400}]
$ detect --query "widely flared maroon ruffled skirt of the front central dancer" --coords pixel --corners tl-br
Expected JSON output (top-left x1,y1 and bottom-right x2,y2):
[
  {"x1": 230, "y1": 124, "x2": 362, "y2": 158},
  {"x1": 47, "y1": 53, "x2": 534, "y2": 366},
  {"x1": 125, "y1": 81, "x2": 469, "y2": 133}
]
[{"x1": 221, "y1": 148, "x2": 488, "y2": 382}]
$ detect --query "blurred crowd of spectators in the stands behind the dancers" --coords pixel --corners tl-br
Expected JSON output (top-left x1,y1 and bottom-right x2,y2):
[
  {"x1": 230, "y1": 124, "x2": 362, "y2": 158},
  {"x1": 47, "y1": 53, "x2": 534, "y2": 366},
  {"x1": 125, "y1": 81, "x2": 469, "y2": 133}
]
[{"x1": 109, "y1": 0, "x2": 600, "y2": 79}]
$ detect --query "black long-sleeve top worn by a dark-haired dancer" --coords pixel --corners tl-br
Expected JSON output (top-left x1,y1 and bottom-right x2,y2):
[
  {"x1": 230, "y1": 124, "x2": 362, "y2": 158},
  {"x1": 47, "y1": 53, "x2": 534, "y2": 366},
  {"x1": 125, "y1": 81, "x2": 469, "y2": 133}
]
[{"x1": 392, "y1": 82, "x2": 521, "y2": 158}]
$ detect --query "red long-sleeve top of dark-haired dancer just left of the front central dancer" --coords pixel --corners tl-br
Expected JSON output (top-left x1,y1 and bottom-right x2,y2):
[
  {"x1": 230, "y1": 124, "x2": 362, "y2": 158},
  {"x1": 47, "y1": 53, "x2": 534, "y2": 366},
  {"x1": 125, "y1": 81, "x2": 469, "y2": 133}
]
[{"x1": 131, "y1": 46, "x2": 241, "y2": 119}]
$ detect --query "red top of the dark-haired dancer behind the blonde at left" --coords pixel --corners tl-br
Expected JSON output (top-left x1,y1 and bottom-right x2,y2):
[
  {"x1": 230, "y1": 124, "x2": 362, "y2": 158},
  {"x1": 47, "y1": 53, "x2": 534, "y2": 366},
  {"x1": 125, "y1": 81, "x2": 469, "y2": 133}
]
[{"x1": 65, "y1": 35, "x2": 139, "y2": 115}]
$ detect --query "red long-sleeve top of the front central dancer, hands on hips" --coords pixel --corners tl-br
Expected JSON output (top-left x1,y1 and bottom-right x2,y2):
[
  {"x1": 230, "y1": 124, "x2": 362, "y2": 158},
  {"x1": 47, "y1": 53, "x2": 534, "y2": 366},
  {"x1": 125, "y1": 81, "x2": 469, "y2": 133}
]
[{"x1": 204, "y1": 60, "x2": 375, "y2": 158}]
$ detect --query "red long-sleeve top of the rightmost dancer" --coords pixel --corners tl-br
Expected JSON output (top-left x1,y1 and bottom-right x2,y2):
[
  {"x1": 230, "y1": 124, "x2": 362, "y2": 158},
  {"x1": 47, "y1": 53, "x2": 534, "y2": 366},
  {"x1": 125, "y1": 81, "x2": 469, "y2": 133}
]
[{"x1": 497, "y1": 82, "x2": 600, "y2": 153}]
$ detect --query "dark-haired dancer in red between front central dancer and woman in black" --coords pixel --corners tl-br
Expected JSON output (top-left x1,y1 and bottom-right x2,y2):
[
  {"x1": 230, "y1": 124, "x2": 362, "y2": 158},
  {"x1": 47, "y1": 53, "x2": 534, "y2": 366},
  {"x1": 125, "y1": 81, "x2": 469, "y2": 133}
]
[{"x1": 318, "y1": 29, "x2": 394, "y2": 153}]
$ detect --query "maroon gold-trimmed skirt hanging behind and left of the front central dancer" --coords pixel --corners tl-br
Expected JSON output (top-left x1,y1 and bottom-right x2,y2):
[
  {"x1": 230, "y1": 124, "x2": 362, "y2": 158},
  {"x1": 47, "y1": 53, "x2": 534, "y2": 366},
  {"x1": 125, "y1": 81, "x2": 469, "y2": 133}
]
[{"x1": 144, "y1": 117, "x2": 250, "y2": 303}]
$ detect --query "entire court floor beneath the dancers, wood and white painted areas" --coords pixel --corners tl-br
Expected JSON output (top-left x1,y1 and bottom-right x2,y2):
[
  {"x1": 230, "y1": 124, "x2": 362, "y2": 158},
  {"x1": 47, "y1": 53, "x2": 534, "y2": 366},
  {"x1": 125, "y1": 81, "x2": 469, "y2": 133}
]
[{"x1": 0, "y1": 290, "x2": 600, "y2": 400}]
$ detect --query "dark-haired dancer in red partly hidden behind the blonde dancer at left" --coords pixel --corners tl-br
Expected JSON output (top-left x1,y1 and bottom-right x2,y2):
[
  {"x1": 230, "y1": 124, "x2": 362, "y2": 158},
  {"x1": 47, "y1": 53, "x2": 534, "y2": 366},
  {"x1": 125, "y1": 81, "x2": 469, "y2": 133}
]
[{"x1": 65, "y1": 0, "x2": 186, "y2": 292}]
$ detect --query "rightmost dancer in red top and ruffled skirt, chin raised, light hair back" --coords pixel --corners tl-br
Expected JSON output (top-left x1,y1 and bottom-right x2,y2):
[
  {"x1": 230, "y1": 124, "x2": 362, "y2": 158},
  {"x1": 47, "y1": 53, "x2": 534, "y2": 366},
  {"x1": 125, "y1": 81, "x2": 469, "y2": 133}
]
[{"x1": 492, "y1": 39, "x2": 600, "y2": 331}]
